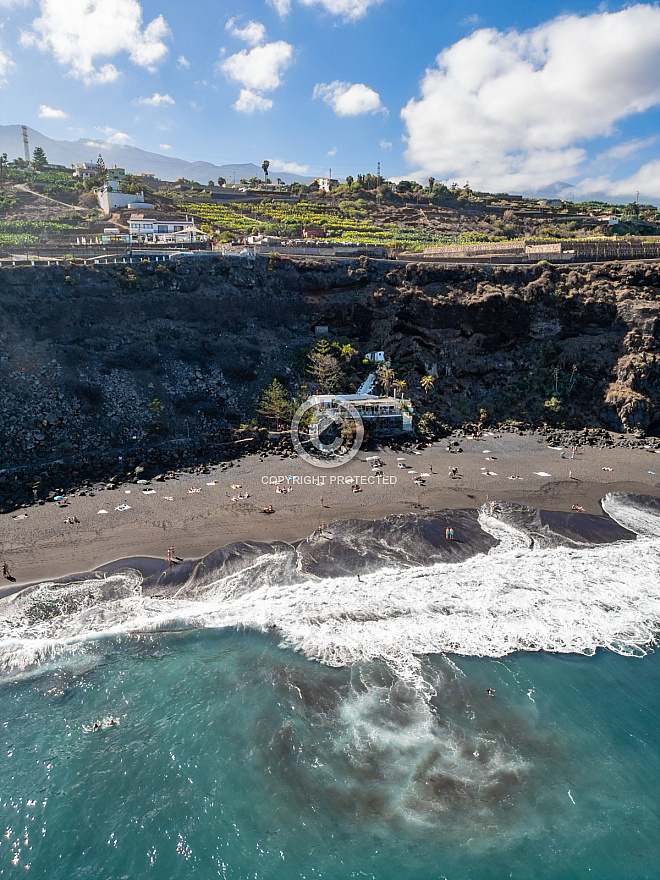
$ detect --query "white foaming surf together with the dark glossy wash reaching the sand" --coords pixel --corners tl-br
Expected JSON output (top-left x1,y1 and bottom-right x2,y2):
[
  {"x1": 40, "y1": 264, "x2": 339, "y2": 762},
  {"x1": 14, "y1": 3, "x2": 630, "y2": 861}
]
[{"x1": 0, "y1": 494, "x2": 660, "y2": 678}]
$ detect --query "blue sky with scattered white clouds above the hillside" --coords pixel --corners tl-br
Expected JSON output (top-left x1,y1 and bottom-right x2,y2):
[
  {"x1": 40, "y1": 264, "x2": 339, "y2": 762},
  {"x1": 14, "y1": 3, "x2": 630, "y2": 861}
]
[{"x1": 0, "y1": 0, "x2": 660, "y2": 201}]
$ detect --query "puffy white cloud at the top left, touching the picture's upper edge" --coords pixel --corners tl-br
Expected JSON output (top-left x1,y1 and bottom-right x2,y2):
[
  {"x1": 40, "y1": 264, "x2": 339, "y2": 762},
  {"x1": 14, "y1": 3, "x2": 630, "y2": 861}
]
[{"x1": 21, "y1": 0, "x2": 170, "y2": 83}]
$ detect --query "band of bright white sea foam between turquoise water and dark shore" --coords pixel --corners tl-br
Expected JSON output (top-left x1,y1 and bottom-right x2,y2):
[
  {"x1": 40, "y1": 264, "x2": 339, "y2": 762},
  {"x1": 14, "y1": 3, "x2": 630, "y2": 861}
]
[{"x1": 0, "y1": 496, "x2": 660, "y2": 676}]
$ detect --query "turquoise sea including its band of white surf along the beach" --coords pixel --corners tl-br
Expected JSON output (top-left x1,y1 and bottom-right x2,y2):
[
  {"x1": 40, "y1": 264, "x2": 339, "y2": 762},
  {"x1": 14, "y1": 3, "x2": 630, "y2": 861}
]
[{"x1": 0, "y1": 499, "x2": 660, "y2": 880}]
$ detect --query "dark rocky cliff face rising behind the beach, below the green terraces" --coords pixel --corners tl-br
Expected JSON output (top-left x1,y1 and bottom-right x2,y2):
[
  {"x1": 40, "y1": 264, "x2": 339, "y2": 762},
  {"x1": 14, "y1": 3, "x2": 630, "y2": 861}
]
[{"x1": 0, "y1": 251, "x2": 660, "y2": 506}]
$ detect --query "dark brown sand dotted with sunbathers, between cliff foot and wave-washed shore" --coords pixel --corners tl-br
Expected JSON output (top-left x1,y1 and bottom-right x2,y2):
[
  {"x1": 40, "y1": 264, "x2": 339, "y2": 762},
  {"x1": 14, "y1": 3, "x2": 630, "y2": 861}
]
[{"x1": 0, "y1": 434, "x2": 660, "y2": 596}]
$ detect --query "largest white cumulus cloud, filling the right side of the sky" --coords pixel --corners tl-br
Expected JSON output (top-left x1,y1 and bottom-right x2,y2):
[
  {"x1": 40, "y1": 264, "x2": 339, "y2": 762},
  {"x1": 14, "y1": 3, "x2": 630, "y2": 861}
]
[{"x1": 401, "y1": 4, "x2": 660, "y2": 191}]
